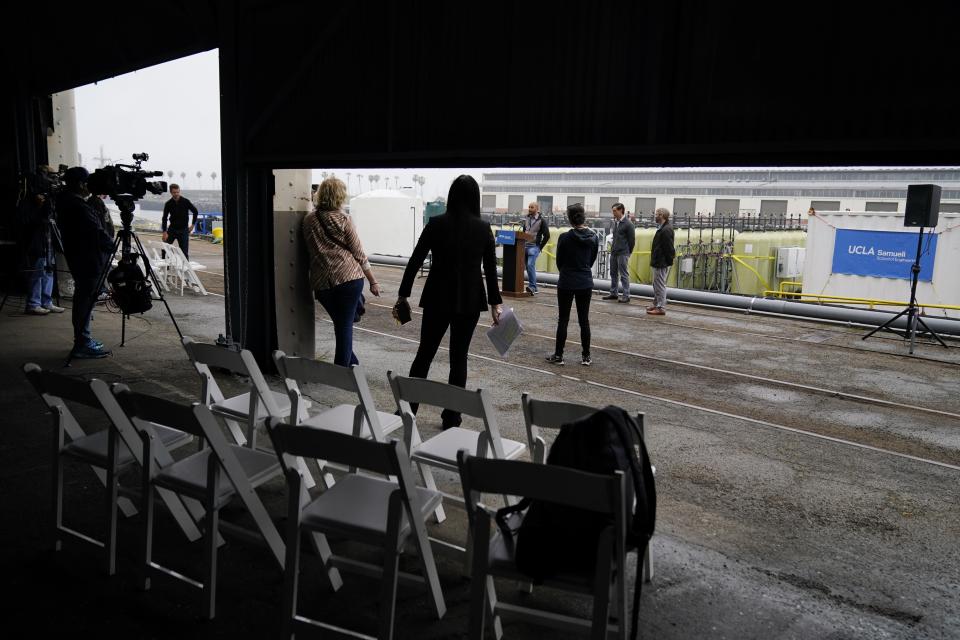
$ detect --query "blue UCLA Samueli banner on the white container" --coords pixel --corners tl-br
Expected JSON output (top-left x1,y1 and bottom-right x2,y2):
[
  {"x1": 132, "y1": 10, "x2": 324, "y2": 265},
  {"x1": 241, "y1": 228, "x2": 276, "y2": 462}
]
[{"x1": 833, "y1": 229, "x2": 938, "y2": 282}]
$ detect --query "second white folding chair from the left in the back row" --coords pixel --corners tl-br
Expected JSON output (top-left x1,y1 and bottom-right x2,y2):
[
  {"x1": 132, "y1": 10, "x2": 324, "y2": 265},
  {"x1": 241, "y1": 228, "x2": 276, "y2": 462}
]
[{"x1": 273, "y1": 350, "x2": 403, "y2": 486}]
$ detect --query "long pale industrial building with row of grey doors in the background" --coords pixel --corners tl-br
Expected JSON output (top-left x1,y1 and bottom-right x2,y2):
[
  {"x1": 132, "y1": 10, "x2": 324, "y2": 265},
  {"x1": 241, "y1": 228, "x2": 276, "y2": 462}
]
[{"x1": 481, "y1": 167, "x2": 960, "y2": 217}]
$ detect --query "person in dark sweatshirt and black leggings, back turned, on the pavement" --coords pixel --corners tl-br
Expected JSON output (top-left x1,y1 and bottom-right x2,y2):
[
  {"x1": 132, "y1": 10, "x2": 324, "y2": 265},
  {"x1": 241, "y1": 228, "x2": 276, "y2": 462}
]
[{"x1": 547, "y1": 203, "x2": 600, "y2": 366}]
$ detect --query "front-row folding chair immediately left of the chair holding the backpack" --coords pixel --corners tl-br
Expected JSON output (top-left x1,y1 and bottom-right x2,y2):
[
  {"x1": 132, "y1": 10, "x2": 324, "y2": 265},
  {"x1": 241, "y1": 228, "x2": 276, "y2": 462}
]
[{"x1": 269, "y1": 419, "x2": 446, "y2": 640}]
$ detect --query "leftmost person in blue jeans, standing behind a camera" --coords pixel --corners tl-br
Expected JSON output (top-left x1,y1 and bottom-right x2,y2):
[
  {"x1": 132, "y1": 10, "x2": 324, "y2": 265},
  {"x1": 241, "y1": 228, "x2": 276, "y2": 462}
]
[{"x1": 18, "y1": 166, "x2": 64, "y2": 316}]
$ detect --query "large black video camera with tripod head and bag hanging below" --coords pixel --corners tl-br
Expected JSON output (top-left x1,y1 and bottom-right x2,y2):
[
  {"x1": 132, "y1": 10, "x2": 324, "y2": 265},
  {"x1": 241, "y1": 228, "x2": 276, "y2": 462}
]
[{"x1": 87, "y1": 153, "x2": 167, "y2": 315}]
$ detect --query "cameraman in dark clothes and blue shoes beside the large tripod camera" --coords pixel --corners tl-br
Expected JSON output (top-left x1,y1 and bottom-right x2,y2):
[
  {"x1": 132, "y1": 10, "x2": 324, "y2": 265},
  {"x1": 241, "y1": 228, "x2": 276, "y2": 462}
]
[{"x1": 57, "y1": 167, "x2": 113, "y2": 358}]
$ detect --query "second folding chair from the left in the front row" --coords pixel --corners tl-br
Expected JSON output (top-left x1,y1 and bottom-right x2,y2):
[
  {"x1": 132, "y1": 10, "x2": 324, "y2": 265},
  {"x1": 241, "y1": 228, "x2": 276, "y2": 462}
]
[{"x1": 114, "y1": 385, "x2": 284, "y2": 619}]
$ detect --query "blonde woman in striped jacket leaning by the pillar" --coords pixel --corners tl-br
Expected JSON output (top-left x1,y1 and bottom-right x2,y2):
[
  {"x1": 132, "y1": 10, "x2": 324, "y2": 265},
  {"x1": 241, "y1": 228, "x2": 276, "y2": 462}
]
[{"x1": 303, "y1": 178, "x2": 380, "y2": 367}]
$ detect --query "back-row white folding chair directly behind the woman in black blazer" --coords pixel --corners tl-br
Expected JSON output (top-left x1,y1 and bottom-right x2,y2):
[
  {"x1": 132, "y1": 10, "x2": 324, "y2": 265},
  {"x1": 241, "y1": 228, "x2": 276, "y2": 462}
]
[{"x1": 387, "y1": 371, "x2": 526, "y2": 522}]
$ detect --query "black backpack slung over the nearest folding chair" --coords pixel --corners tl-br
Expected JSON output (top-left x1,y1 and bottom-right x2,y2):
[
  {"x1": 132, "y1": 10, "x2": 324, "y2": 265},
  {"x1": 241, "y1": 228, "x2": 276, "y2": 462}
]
[{"x1": 496, "y1": 405, "x2": 657, "y2": 638}]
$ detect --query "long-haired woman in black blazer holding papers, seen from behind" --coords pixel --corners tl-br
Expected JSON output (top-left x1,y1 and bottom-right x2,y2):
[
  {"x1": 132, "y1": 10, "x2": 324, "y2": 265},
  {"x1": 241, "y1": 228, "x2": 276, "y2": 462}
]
[{"x1": 399, "y1": 175, "x2": 503, "y2": 429}]
